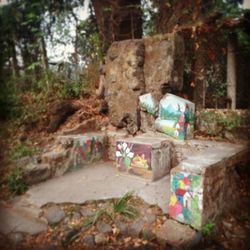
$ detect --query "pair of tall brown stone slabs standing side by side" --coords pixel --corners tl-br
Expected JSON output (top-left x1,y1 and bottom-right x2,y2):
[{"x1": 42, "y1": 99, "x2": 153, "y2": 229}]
[{"x1": 105, "y1": 34, "x2": 184, "y2": 134}]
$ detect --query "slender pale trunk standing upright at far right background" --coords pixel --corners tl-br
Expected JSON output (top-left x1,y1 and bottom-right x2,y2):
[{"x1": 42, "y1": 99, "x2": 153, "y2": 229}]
[{"x1": 227, "y1": 33, "x2": 236, "y2": 109}]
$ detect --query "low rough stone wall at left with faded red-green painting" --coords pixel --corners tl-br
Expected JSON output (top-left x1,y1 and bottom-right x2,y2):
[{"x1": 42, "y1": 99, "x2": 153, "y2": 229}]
[{"x1": 41, "y1": 133, "x2": 107, "y2": 177}]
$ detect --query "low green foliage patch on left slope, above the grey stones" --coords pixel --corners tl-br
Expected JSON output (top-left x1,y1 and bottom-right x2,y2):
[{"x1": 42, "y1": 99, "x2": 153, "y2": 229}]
[{"x1": 10, "y1": 142, "x2": 38, "y2": 160}]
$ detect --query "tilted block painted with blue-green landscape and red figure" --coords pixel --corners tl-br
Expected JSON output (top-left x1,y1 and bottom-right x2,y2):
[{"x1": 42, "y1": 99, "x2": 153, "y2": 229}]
[{"x1": 155, "y1": 94, "x2": 195, "y2": 140}]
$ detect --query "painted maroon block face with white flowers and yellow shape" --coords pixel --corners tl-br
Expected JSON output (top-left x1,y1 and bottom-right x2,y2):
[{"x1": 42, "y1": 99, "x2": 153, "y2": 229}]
[{"x1": 116, "y1": 141, "x2": 152, "y2": 178}]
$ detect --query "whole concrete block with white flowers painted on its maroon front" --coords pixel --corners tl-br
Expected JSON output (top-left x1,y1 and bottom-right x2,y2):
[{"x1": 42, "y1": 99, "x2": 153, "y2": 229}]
[{"x1": 116, "y1": 137, "x2": 170, "y2": 181}]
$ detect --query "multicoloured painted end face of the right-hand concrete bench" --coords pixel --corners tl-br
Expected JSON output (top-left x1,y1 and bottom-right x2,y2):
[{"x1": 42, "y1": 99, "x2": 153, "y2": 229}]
[{"x1": 169, "y1": 172, "x2": 202, "y2": 228}]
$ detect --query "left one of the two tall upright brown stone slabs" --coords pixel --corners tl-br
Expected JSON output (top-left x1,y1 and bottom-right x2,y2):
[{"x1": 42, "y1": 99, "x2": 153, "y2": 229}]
[{"x1": 105, "y1": 40, "x2": 144, "y2": 134}]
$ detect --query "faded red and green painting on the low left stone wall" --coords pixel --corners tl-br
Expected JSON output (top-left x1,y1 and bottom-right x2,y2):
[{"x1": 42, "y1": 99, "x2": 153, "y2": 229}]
[{"x1": 76, "y1": 137, "x2": 104, "y2": 162}]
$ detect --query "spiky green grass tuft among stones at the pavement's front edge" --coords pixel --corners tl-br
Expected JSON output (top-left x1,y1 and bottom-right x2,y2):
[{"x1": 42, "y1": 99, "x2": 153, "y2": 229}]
[{"x1": 112, "y1": 192, "x2": 139, "y2": 217}]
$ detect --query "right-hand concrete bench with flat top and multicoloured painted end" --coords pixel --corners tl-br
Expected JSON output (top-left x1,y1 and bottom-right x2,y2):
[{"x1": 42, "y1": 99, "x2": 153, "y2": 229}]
[{"x1": 169, "y1": 142, "x2": 249, "y2": 229}]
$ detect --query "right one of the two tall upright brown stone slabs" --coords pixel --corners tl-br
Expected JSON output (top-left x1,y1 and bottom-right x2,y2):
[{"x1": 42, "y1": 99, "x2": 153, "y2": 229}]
[{"x1": 144, "y1": 33, "x2": 185, "y2": 101}]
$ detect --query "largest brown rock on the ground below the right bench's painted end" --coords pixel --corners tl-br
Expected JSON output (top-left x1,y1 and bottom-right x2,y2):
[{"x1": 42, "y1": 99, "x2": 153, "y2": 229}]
[{"x1": 156, "y1": 220, "x2": 202, "y2": 249}]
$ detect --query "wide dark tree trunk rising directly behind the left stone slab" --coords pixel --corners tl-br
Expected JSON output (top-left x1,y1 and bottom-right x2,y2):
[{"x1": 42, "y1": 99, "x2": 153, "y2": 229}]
[{"x1": 92, "y1": 0, "x2": 142, "y2": 52}]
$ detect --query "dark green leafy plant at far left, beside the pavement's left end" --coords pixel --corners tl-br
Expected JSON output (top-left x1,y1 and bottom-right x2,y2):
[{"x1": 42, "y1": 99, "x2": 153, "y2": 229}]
[{"x1": 7, "y1": 168, "x2": 28, "y2": 195}]
